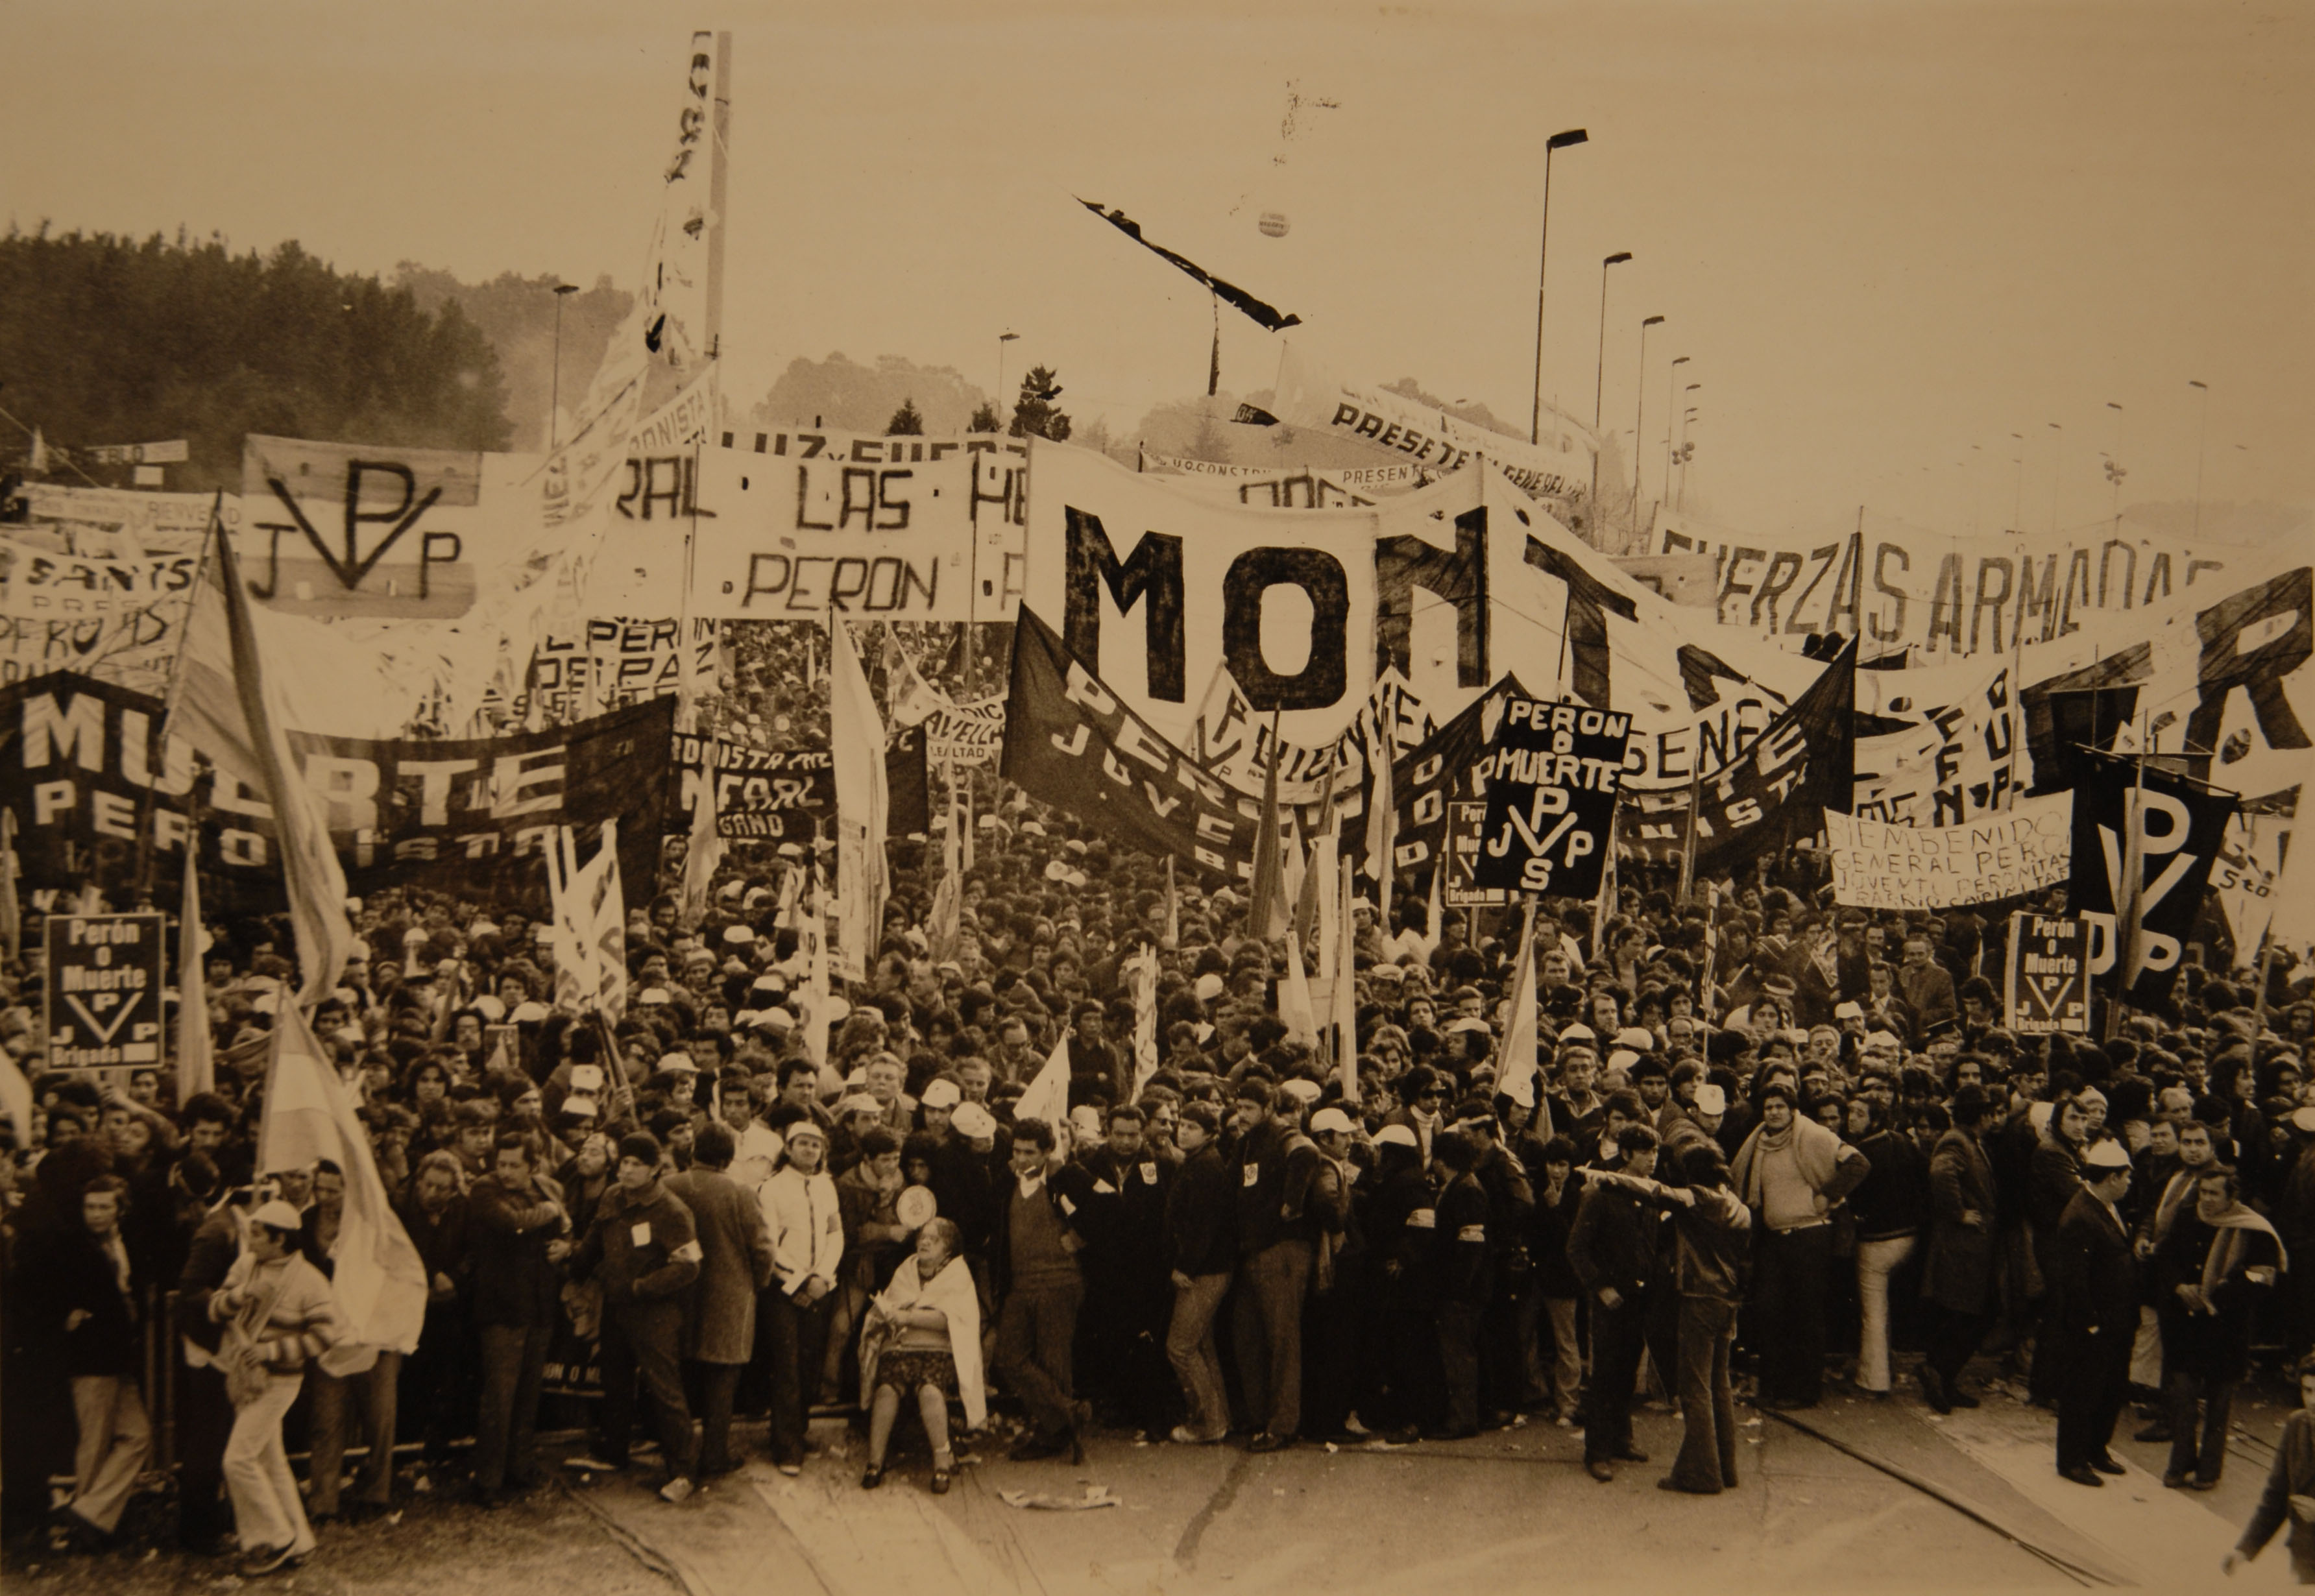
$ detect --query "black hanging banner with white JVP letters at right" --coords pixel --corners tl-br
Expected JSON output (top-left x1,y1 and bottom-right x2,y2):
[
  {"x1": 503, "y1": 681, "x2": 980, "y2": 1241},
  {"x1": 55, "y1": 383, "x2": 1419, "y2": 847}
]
[{"x1": 2067, "y1": 751, "x2": 2241, "y2": 1008}]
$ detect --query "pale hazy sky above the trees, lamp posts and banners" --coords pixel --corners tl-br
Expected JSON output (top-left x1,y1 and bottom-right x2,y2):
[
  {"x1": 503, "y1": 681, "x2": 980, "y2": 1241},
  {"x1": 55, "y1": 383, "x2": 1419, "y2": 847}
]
[{"x1": 0, "y1": 0, "x2": 2315, "y2": 533}]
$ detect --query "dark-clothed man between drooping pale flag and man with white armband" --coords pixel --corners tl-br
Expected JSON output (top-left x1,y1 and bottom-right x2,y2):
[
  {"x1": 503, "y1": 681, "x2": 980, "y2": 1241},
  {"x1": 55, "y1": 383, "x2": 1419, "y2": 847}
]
[{"x1": 465, "y1": 1133, "x2": 572, "y2": 1503}]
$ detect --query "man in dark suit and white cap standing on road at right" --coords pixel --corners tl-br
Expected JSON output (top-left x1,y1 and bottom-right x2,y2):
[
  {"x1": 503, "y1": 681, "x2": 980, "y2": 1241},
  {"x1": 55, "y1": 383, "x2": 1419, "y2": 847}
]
[{"x1": 2055, "y1": 1142, "x2": 2139, "y2": 1485}]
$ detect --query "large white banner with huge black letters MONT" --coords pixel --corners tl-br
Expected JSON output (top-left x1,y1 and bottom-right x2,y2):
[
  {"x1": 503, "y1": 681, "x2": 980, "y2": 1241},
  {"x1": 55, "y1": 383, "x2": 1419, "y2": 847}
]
[{"x1": 1028, "y1": 440, "x2": 1822, "y2": 788}]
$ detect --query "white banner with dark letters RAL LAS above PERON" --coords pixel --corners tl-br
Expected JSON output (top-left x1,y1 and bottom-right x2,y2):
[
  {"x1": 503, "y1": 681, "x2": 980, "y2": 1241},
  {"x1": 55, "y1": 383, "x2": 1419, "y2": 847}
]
[{"x1": 588, "y1": 429, "x2": 1028, "y2": 621}]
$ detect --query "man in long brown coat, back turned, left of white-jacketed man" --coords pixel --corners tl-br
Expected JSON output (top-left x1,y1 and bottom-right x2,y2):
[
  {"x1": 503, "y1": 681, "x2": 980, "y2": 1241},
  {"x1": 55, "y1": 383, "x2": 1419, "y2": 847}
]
[{"x1": 667, "y1": 1118, "x2": 771, "y2": 1480}]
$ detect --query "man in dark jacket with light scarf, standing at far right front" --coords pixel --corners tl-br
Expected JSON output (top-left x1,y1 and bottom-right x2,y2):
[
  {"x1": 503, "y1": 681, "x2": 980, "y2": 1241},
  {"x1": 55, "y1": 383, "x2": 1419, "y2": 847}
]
[{"x1": 2155, "y1": 1163, "x2": 2287, "y2": 1492}]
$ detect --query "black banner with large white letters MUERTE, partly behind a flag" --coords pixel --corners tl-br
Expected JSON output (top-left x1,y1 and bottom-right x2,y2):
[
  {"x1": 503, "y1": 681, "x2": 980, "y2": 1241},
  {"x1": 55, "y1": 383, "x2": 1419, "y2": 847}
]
[{"x1": 0, "y1": 674, "x2": 673, "y2": 913}]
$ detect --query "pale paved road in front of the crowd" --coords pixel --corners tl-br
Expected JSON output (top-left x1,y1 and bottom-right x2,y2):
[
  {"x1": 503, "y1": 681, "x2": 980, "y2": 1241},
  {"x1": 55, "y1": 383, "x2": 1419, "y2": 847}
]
[{"x1": 579, "y1": 1394, "x2": 2290, "y2": 1596}]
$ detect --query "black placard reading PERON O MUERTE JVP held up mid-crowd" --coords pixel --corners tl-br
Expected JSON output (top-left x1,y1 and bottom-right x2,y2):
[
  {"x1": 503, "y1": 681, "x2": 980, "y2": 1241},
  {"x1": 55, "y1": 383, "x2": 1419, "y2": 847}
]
[{"x1": 1472, "y1": 697, "x2": 1632, "y2": 899}]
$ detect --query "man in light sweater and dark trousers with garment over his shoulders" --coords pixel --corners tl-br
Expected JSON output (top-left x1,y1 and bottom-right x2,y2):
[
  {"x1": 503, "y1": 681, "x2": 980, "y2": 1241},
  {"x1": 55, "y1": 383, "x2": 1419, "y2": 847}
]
[{"x1": 1729, "y1": 1082, "x2": 1873, "y2": 1409}]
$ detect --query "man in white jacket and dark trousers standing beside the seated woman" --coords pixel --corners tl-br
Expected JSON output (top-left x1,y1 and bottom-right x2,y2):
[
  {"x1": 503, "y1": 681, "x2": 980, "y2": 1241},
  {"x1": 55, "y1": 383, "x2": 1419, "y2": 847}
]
[{"x1": 757, "y1": 1114, "x2": 845, "y2": 1475}]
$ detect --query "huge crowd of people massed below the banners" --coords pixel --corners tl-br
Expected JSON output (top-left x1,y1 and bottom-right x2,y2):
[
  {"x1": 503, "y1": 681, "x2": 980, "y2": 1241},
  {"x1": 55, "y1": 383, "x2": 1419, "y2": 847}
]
[{"x1": 0, "y1": 630, "x2": 2315, "y2": 1575}]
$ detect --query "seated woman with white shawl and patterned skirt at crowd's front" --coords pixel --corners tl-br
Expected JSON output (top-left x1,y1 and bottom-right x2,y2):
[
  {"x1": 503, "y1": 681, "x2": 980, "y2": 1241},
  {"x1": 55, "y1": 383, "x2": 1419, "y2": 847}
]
[{"x1": 861, "y1": 1218, "x2": 989, "y2": 1496}]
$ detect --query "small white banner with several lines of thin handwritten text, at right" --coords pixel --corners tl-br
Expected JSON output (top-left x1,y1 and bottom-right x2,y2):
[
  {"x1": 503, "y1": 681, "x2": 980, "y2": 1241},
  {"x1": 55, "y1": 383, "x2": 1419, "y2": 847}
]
[{"x1": 1824, "y1": 792, "x2": 2074, "y2": 908}]
